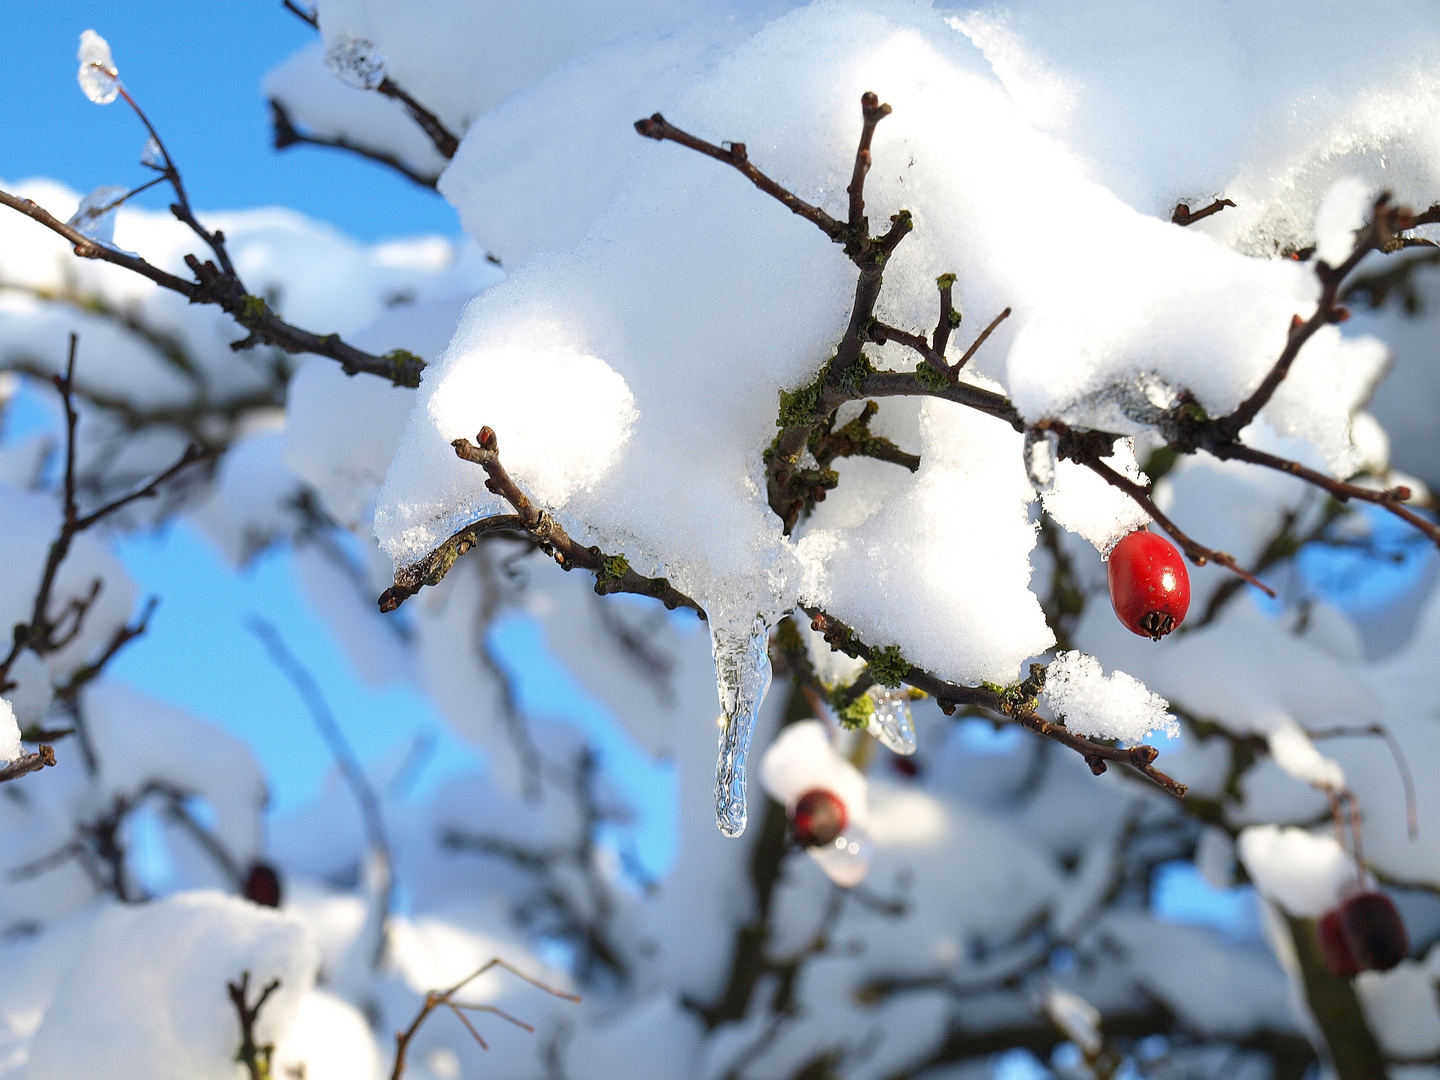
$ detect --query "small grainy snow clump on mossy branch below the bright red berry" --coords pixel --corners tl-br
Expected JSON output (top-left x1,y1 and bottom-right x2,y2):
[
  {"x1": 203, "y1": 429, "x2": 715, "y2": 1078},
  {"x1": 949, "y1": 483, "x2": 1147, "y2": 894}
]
[{"x1": 1041, "y1": 651, "x2": 1179, "y2": 743}]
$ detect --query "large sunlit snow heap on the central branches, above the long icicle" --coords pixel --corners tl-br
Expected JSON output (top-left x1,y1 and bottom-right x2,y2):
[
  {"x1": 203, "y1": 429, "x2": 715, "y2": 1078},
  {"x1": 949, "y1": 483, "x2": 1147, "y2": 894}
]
[{"x1": 376, "y1": 3, "x2": 1405, "y2": 694}]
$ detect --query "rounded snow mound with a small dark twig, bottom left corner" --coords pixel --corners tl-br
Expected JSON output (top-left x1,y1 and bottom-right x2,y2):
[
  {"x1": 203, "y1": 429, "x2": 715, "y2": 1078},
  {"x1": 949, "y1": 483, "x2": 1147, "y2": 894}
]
[{"x1": 26, "y1": 893, "x2": 318, "y2": 1080}]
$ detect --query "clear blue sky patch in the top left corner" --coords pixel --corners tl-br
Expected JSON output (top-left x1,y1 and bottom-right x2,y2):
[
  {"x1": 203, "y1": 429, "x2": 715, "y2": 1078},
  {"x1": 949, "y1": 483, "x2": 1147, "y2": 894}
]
[{"x1": 0, "y1": 0, "x2": 459, "y2": 240}]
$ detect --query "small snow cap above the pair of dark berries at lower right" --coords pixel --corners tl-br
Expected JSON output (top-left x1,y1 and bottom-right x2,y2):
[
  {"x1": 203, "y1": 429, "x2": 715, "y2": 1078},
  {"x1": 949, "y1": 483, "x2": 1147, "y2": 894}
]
[{"x1": 1237, "y1": 825, "x2": 1356, "y2": 919}]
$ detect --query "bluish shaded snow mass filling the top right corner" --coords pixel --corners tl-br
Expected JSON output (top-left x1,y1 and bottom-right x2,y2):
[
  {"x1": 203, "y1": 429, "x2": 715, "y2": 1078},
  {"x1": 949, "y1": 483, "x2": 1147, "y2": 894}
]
[{"x1": 955, "y1": 0, "x2": 1440, "y2": 255}]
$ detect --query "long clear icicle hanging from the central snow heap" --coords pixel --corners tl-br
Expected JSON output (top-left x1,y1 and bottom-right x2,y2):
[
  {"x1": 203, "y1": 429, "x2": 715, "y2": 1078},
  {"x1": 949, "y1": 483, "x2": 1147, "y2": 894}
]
[{"x1": 710, "y1": 616, "x2": 770, "y2": 837}]
